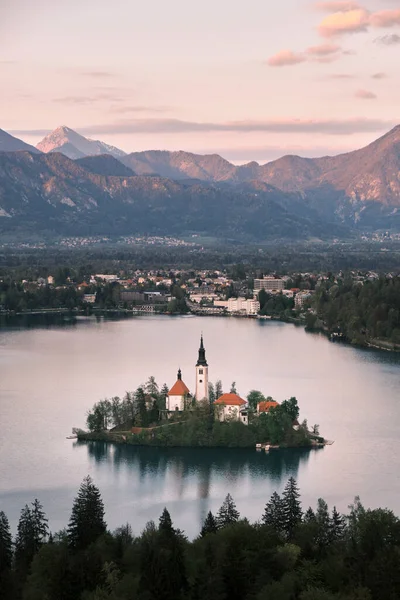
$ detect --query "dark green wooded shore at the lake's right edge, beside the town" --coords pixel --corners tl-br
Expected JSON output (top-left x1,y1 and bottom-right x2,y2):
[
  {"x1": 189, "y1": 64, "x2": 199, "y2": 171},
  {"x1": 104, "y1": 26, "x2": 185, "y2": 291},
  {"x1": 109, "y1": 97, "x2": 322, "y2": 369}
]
[{"x1": 307, "y1": 277, "x2": 400, "y2": 344}]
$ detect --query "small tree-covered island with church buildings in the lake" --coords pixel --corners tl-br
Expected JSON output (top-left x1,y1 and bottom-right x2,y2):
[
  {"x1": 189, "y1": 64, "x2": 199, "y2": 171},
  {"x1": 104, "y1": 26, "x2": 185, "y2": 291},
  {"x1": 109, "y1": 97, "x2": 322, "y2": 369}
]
[{"x1": 75, "y1": 336, "x2": 332, "y2": 451}]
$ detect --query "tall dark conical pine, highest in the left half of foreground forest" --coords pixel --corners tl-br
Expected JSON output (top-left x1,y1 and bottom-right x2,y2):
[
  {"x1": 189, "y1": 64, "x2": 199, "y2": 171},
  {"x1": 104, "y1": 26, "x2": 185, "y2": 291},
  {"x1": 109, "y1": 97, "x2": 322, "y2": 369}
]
[{"x1": 68, "y1": 475, "x2": 107, "y2": 550}]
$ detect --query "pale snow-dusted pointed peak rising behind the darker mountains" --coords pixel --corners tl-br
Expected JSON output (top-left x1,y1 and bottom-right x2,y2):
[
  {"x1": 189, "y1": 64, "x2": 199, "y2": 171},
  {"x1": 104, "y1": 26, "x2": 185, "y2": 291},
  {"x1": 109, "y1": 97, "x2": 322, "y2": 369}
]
[{"x1": 36, "y1": 125, "x2": 125, "y2": 159}]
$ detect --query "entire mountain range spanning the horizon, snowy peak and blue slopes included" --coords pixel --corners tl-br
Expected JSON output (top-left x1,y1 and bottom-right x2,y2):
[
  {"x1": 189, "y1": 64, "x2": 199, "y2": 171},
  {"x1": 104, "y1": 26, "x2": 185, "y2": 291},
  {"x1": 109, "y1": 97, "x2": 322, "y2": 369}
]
[{"x1": 0, "y1": 126, "x2": 400, "y2": 240}]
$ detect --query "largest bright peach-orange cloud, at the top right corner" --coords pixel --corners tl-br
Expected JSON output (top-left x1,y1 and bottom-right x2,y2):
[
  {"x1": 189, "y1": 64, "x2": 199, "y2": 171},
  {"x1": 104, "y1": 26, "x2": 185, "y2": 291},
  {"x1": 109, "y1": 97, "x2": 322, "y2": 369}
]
[{"x1": 318, "y1": 7, "x2": 400, "y2": 38}]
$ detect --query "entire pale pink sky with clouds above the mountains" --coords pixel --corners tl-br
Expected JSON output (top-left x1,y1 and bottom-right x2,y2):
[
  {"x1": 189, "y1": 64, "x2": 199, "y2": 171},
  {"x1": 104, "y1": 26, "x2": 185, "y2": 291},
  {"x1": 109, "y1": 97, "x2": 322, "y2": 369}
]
[{"x1": 0, "y1": 0, "x2": 400, "y2": 162}]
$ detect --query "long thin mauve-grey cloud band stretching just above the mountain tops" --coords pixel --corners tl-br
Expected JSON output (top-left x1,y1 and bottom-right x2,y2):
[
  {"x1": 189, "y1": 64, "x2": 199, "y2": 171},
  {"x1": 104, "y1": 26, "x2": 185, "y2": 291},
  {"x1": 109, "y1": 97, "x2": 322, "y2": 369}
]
[{"x1": 10, "y1": 118, "x2": 396, "y2": 136}]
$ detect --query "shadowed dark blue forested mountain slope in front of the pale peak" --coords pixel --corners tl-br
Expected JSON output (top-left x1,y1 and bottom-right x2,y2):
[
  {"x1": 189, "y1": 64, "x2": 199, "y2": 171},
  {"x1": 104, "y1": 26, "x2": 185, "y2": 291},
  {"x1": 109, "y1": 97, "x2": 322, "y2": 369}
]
[{"x1": 0, "y1": 152, "x2": 349, "y2": 241}]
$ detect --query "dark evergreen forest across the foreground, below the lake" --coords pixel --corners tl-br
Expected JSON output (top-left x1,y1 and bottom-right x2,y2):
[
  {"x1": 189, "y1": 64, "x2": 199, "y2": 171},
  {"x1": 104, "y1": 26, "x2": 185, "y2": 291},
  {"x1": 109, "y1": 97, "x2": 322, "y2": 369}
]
[{"x1": 0, "y1": 477, "x2": 400, "y2": 600}]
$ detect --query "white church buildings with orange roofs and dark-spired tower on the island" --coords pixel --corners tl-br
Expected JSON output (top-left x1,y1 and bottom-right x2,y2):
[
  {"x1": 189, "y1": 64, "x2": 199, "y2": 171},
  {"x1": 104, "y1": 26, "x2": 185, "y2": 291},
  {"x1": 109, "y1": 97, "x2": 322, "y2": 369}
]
[{"x1": 166, "y1": 335, "x2": 248, "y2": 425}]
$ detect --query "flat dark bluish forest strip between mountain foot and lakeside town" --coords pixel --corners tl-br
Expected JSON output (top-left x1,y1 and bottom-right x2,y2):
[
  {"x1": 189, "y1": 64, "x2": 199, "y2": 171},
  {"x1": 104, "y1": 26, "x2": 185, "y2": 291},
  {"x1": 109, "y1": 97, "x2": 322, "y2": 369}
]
[{"x1": 0, "y1": 239, "x2": 400, "y2": 279}]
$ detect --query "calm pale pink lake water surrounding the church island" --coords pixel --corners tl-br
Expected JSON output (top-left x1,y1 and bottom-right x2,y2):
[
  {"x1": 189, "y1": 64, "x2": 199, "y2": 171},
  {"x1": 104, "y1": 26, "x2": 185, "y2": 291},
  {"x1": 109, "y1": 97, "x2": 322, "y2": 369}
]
[{"x1": 0, "y1": 317, "x2": 400, "y2": 536}]
